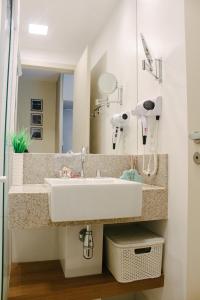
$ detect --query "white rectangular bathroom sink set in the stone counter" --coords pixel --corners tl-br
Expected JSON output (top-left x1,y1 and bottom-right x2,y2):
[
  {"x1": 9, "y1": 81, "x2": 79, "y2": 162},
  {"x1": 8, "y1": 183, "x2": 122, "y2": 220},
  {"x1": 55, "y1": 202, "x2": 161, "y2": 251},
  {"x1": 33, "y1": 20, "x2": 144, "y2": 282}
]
[{"x1": 45, "y1": 177, "x2": 142, "y2": 222}]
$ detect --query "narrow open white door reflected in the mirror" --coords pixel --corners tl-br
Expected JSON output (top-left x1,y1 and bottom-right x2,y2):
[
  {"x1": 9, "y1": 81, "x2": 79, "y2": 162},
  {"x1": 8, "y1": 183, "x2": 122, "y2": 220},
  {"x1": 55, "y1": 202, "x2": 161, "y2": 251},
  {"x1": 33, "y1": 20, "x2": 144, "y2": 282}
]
[{"x1": 72, "y1": 48, "x2": 90, "y2": 152}]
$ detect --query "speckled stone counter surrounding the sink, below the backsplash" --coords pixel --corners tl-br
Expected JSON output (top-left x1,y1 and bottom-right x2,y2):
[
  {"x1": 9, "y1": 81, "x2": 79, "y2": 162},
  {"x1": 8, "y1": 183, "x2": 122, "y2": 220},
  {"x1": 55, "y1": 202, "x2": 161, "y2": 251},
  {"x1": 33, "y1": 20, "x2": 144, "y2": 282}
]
[{"x1": 9, "y1": 184, "x2": 168, "y2": 229}]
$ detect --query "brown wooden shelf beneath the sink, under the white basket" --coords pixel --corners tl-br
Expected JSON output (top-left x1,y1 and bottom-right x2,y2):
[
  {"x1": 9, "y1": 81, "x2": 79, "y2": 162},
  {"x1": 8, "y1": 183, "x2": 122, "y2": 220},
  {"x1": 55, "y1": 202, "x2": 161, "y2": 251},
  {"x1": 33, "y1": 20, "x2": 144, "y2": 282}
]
[{"x1": 8, "y1": 261, "x2": 164, "y2": 300}]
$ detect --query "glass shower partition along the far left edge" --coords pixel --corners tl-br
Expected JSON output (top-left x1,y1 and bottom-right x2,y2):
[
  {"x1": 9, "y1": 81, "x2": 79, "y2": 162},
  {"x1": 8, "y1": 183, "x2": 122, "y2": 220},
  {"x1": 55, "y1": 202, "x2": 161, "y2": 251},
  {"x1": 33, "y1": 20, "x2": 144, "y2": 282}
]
[{"x1": 0, "y1": 0, "x2": 12, "y2": 299}]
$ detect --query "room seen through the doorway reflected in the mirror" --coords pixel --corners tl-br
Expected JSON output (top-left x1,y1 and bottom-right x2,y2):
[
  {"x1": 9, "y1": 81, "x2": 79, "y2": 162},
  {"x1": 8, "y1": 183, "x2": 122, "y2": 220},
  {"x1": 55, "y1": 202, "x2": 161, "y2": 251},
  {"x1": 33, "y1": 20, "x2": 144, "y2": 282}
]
[{"x1": 17, "y1": 68, "x2": 74, "y2": 153}]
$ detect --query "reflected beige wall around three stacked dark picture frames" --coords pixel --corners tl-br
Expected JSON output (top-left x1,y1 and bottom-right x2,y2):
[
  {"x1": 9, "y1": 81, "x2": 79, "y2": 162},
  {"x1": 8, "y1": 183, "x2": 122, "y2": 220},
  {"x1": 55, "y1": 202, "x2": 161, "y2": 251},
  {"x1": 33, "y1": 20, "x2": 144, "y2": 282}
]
[{"x1": 17, "y1": 77, "x2": 56, "y2": 153}]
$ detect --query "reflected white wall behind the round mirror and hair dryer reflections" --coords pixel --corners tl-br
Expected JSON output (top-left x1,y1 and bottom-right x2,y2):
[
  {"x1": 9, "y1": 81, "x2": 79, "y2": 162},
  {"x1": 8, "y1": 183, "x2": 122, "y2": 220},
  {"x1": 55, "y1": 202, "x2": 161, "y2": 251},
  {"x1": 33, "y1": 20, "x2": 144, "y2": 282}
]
[{"x1": 90, "y1": 0, "x2": 137, "y2": 154}]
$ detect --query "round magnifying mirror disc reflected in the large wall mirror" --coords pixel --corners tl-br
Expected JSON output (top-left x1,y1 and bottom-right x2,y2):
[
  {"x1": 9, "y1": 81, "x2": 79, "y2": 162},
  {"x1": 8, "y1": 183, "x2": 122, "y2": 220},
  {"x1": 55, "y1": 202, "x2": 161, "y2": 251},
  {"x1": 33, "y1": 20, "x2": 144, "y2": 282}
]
[{"x1": 98, "y1": 73, "x2": 117, "y2": 94}]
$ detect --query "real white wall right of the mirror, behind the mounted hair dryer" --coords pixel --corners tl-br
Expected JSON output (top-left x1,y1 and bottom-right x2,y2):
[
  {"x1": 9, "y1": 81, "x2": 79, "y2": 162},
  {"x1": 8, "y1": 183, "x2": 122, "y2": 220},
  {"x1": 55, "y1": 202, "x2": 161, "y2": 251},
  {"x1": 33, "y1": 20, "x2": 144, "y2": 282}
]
[{"x1": 138, "y1": 0, "x2": 189, "y2": 300}]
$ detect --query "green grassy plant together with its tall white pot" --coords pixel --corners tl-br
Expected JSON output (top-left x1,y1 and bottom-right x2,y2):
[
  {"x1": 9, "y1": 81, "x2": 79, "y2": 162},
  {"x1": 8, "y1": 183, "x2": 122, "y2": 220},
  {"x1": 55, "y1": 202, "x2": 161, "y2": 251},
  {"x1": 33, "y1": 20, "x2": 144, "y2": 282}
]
[{"x1": 11, "y1": 129, "x2": 30, "y2": 185}]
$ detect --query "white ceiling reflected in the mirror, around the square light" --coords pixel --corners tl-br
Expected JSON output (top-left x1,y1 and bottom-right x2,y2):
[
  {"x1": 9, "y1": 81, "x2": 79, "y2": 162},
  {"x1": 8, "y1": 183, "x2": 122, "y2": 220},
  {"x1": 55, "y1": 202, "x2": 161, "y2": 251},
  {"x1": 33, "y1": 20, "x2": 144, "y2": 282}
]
[{"x1": 20, "y1": 0, "x2": 120, "y2": 64}]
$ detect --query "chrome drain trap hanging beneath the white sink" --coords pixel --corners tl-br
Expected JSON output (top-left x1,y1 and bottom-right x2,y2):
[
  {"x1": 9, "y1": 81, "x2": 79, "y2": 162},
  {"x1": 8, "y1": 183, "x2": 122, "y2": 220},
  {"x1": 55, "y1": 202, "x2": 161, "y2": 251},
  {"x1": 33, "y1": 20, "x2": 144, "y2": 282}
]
[{"x1": 79, "y1": 225, "x2": 94, "y2": 259}]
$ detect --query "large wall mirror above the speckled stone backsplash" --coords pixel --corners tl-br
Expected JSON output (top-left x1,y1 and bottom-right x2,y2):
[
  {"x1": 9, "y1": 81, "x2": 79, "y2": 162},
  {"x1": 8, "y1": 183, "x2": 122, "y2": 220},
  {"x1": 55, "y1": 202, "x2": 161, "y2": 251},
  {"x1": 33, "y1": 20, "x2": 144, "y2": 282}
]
[{"x1": 16, "y1": 0, "x2": 137, "y2": 154}]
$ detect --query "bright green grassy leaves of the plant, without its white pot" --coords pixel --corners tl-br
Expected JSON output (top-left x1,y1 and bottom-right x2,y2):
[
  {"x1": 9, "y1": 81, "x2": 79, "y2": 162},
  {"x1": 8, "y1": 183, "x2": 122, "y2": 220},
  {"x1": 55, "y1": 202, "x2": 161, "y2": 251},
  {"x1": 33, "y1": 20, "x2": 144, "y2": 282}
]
[{"x1": 11, "y1": 129, "x2": 30, "y2": 153}]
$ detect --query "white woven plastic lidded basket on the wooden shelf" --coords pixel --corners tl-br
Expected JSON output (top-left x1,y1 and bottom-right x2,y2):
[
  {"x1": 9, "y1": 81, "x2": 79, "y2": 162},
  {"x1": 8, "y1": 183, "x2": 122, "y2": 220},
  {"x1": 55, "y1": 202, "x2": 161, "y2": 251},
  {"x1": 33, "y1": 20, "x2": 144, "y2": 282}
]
[{"x1": 105, "y1": 225, "x2": 164, "y2": 283}]
